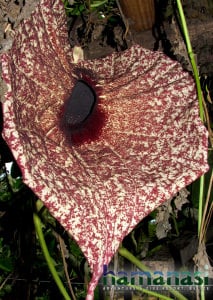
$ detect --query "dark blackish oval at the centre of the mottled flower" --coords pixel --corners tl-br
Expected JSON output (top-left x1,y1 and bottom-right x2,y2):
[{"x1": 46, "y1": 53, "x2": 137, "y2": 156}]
[{"x1": 64, "y1": 80, "x2": 96, "y2": 129}]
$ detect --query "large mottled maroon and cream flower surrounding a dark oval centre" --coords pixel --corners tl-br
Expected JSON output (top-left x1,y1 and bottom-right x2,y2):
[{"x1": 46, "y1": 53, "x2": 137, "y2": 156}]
[{"x1": 1, "y1": 0, "x2": 208, "y2": 299}]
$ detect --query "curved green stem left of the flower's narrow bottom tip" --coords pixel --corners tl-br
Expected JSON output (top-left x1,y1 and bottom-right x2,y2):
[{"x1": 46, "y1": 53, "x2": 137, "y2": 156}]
[{"x1": 33, "y1": 206, "x2": 71, "y2": 300}]
